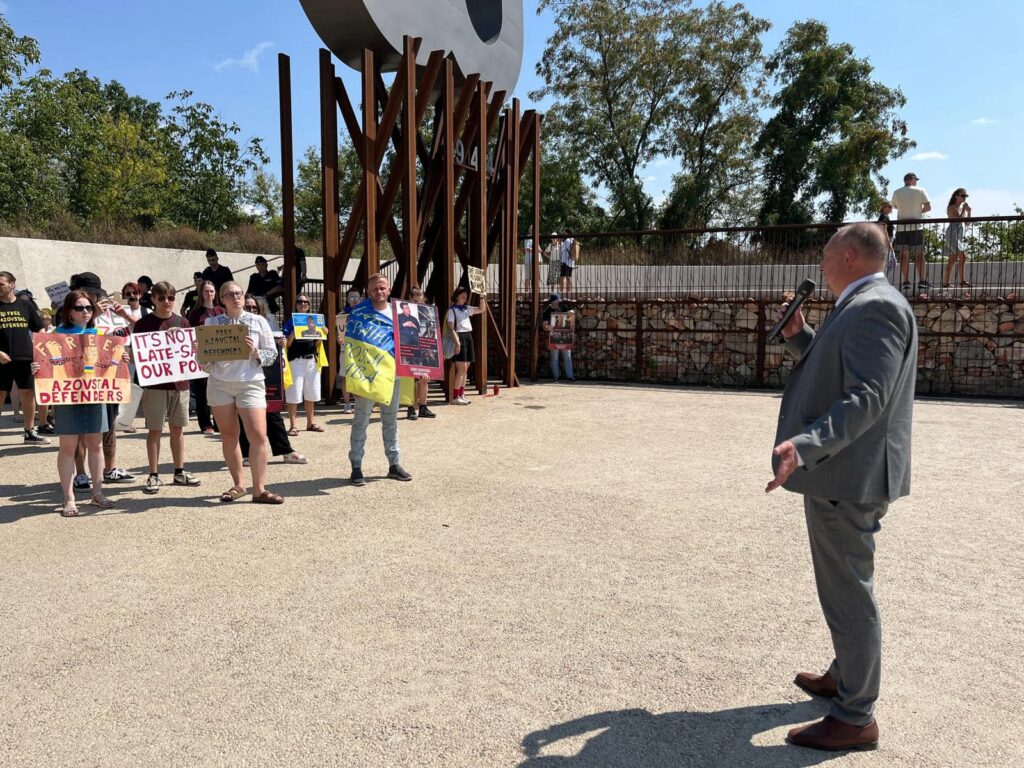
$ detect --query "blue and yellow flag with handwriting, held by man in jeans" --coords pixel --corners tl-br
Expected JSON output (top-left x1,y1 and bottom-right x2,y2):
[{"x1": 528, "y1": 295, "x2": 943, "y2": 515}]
[{"x1": 345, "y1": 299, "x2": 395, "y2": 406}]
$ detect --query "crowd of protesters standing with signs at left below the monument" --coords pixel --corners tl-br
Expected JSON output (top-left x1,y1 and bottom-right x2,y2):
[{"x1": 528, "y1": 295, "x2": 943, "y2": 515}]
[{"x1": 0, "y1": 249, "x2": 520, "y2": 517}]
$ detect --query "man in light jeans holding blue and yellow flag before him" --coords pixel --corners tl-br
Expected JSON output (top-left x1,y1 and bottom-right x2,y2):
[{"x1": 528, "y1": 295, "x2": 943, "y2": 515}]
[{"x1": 345, "y1": 272, "x2": 413, "y2": 486}]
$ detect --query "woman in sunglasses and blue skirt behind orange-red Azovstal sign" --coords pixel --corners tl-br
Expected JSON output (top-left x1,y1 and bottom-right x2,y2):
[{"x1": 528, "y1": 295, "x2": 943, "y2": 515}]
[{"x1": 51, "y1": 291, "x2": 114, "y2": 517}]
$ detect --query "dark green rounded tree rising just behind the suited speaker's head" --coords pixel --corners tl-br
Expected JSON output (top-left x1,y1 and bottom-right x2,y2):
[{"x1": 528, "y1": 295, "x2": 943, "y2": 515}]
[{"x1": 756, "y1": 20, "x2": 915, "y2": 224}]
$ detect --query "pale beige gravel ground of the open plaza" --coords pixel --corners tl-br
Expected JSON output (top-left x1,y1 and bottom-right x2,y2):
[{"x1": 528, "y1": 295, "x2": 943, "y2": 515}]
[{"x1": 0, "y1": 384, "x2": 1024, "y2": 768}]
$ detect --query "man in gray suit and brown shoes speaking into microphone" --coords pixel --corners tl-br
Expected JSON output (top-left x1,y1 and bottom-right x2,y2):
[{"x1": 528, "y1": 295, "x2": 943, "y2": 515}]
[{"x1": 766, "y1": 223, "x2": 918, "y2": 750}]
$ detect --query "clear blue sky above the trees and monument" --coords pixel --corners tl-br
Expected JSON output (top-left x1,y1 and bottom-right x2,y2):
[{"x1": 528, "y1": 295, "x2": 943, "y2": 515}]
[{"x1": 0, "y1": 0, "x2": 1024, "y2": 215}]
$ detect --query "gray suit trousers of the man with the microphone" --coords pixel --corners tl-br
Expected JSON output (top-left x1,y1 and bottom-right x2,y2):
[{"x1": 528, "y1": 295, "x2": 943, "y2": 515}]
[{"x1": 804, "y1": 496, "x2": 889, "y2": 725}]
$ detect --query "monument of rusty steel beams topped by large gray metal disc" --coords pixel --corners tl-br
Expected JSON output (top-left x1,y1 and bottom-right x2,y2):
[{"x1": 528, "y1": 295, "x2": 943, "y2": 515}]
[{"x1": 279, "y1": 0, "x2": 542, "y2": 400}]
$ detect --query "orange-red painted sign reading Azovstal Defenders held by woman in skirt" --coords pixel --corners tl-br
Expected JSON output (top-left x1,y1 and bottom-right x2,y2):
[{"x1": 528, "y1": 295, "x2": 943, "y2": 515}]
[{"x1": 32, "y1": 334, "x2": 131, "y2": 406}]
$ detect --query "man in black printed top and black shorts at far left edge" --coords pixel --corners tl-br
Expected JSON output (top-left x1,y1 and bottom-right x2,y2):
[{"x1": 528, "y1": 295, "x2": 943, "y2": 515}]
[{"x1": 0, "y1": 271, "x2": 50, "y2": 445}]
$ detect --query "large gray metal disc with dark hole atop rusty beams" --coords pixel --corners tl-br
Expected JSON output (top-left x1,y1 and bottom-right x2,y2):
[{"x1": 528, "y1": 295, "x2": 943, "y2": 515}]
[{"x1": 299, "y1": 0, "x2": 523, "y2": 93}]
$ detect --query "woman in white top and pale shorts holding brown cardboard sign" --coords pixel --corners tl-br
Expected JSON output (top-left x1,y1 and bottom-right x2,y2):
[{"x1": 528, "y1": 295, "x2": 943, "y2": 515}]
[{"x1": 203, "y1": 282, "x2": 285, "y2": 504}]
